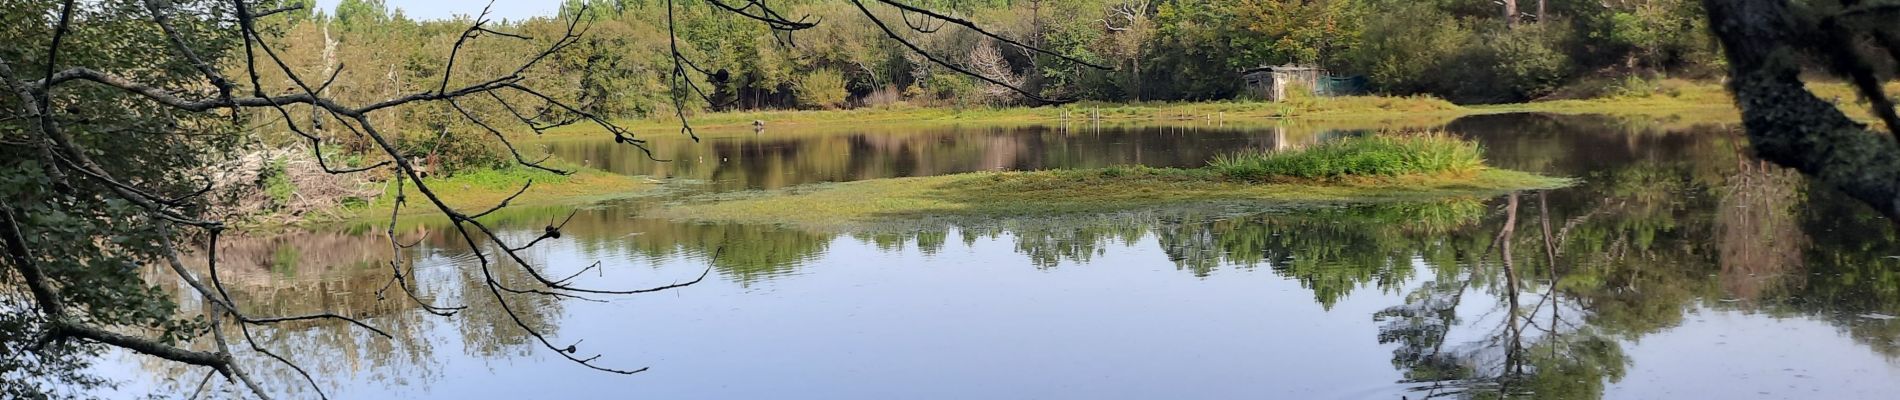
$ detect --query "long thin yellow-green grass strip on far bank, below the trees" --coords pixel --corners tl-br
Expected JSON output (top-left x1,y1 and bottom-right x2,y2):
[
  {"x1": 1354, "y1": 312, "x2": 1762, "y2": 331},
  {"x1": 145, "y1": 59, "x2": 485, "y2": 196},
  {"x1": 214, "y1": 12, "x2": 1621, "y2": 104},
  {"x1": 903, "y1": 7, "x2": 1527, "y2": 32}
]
[{"x1": 528, "y1": 80, "x2": 1900, "y2": 138}]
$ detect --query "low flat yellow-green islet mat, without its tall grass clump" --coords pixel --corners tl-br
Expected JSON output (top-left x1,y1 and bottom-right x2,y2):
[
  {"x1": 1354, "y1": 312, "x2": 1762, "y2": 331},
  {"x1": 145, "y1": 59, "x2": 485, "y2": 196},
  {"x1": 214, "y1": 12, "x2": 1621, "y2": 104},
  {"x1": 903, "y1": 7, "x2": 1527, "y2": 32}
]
[{"x1": 654, "y1": 167, "x2": 1575, "y2": 229}]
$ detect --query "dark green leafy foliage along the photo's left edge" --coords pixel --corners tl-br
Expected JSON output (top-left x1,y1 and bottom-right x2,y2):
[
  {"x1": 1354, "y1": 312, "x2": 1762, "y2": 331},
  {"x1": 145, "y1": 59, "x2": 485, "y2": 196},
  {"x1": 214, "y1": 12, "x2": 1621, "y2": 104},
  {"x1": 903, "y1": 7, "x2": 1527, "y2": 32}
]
[{"x1": 0, "y1": 0, "x2": 243, "y2": 398}]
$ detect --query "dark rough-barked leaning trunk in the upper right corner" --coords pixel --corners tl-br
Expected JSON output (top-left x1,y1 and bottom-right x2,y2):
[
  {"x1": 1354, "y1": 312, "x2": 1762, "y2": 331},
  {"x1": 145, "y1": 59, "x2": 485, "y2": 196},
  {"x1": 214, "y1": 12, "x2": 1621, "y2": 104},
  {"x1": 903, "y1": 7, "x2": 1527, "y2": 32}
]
[{"x1": 1702, "y1": 0, "x2": 1900, "y2": 220}]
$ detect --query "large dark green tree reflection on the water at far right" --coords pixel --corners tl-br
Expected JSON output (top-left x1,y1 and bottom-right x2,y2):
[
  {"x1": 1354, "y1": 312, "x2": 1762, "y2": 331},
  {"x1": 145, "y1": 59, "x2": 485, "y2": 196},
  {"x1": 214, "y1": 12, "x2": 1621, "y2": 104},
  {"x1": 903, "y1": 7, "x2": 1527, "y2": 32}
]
[{"x1": 1379, "y1": 117, "x2": 1900, "y2": 398}]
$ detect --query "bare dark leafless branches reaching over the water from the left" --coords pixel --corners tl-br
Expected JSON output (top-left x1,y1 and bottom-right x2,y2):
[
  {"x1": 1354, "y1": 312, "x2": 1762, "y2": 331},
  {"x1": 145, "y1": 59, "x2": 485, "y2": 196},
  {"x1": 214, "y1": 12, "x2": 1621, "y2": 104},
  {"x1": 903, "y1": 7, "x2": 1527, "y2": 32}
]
[{"x1": 0, "y1": 0, "x2": 1104, "y2": 398}]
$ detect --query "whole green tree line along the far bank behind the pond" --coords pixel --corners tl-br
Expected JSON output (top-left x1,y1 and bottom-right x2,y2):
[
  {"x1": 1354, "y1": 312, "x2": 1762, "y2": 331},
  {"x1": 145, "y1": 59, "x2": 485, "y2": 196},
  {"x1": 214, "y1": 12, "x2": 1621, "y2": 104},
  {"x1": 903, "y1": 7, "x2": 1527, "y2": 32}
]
[{"x1": 283, "y1": 0, "x2": 1721, "y2": 112}]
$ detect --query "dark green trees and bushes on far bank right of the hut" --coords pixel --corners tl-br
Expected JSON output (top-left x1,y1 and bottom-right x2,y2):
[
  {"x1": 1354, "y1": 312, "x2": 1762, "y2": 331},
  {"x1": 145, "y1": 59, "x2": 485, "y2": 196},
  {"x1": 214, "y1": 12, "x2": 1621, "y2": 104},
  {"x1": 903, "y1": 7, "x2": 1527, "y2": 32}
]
[{"x1": 1343, "y1": 0, "x2": 1721, "y2": 102}]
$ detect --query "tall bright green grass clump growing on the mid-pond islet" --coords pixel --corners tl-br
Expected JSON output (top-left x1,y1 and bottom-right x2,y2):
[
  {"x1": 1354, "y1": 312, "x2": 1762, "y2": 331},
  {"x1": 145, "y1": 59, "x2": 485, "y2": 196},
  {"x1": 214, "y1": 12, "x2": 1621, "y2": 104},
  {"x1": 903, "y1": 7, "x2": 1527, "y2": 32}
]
[{"x1": 1208, "y1": 133, "x2": 1484, "y2": 182}]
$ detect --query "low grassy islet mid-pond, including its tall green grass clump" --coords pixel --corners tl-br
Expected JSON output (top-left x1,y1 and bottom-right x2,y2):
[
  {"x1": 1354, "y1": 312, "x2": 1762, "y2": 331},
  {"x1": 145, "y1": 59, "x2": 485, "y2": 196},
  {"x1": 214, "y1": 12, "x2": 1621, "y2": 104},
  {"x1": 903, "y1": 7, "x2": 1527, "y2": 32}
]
[{"x1": 659, "y1": 135, "x2": 1569, "y2": 227}]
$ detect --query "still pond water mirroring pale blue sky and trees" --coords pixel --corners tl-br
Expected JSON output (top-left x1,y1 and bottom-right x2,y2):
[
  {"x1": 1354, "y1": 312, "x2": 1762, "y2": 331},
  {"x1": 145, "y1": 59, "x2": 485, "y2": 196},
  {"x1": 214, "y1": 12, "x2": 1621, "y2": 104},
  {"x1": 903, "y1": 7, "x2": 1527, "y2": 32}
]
[{"x1": 101, "y1": 114, "x2": 1900, "y2": 400}]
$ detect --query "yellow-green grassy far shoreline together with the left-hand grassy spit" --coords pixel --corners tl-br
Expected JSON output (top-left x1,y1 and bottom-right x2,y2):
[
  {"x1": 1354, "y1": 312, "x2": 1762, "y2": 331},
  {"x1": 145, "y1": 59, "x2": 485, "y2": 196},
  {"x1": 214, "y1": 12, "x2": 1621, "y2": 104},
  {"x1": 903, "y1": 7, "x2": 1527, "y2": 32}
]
[{"x1": 260, "y1": 83, "x2": 1831, "y2": 231}]
